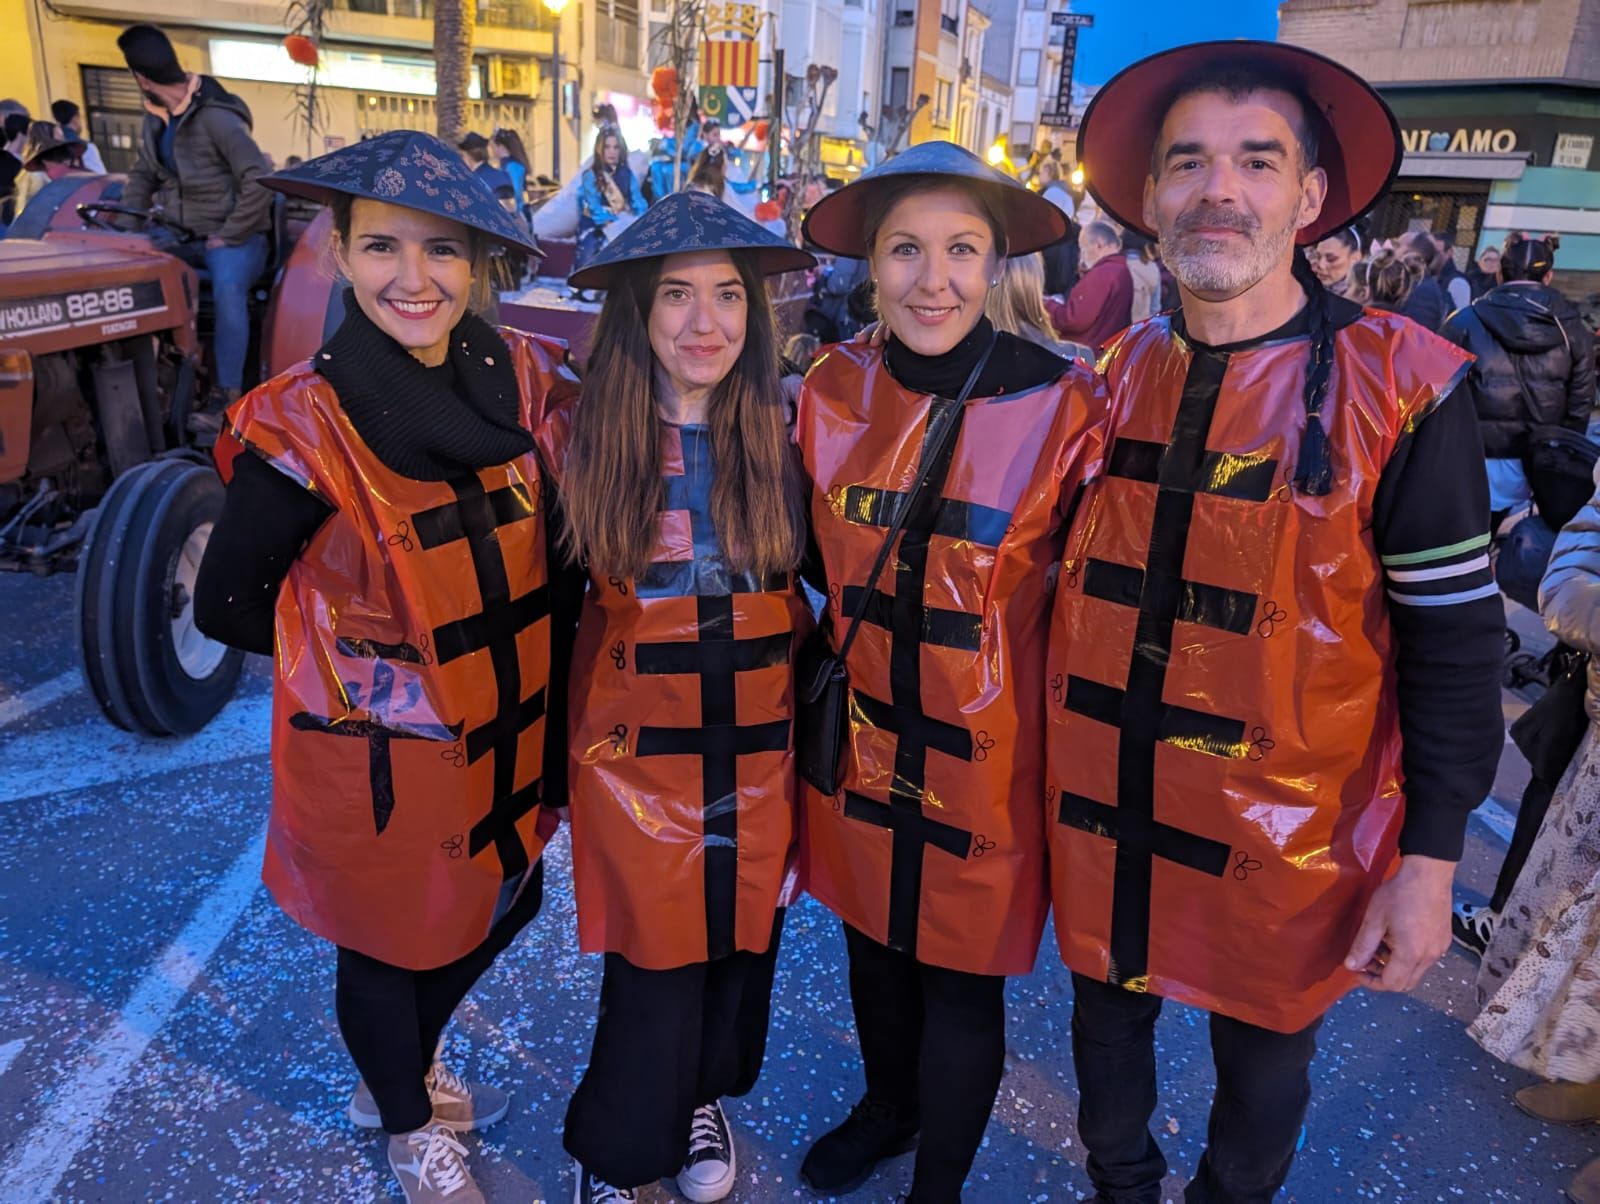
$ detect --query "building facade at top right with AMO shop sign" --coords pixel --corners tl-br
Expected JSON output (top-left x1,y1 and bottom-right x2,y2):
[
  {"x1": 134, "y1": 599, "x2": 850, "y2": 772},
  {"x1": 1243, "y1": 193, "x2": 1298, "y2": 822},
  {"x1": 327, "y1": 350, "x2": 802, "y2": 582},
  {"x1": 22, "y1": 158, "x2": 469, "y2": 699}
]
[{"x1": 1278, "y1": 0, "x2": 1600, "y2": 284}]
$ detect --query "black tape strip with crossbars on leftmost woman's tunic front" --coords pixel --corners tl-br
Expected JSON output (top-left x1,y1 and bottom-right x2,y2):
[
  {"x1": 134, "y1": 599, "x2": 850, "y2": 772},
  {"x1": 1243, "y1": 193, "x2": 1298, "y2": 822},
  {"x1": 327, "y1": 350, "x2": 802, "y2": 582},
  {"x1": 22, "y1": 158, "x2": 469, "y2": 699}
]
[{"x1": 411, "y1": 474, "x2": 550, "y2": 890}]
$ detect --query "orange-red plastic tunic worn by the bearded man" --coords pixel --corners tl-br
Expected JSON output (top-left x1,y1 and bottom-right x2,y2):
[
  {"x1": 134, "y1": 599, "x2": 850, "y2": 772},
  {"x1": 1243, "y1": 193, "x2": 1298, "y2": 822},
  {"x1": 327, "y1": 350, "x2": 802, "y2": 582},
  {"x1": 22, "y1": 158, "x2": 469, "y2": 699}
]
[{"x1": 1045, "y1": 311, "x2": 1469, "y2": 1033}]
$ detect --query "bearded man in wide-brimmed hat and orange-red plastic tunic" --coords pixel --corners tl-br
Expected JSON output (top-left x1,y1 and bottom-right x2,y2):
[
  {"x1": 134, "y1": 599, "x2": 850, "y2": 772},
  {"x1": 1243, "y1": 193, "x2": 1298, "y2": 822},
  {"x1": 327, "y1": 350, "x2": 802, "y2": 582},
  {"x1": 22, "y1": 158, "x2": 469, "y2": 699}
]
[{"x1": 1046, "y1": 42, "x2": 1502, "y2": 1204}]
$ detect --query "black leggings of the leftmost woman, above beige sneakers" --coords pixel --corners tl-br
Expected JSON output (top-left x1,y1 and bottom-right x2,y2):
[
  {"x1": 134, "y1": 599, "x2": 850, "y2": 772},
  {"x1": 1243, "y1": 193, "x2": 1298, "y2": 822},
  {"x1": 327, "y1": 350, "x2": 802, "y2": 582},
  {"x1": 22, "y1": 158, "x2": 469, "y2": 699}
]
[{"x1": 333, "y1": 861, "x2": 544, "y2": 1134}]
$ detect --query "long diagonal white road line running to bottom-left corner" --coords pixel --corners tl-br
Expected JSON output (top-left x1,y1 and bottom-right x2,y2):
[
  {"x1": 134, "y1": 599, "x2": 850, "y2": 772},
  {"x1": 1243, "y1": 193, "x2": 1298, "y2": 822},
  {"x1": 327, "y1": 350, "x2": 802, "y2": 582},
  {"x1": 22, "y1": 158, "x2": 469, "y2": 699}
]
[{"x1": 0, "y1": 831, "x2": 267, "y2": 1204}]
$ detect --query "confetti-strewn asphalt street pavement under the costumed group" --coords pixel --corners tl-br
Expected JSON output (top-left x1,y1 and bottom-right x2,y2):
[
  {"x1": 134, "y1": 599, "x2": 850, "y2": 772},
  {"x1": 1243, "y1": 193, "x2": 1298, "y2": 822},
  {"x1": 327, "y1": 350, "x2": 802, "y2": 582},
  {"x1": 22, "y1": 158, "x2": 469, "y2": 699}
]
[{"x1": 0, "y1": 576, "x2": 1600, "y2": 1204}]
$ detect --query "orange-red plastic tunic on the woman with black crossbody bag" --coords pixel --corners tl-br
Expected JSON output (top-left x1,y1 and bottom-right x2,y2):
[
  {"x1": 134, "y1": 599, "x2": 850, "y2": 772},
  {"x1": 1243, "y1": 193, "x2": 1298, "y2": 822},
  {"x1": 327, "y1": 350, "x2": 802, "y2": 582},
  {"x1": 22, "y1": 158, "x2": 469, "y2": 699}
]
[{"x1": 797, "y1": 344, "x2": 1104, "y2": 973}]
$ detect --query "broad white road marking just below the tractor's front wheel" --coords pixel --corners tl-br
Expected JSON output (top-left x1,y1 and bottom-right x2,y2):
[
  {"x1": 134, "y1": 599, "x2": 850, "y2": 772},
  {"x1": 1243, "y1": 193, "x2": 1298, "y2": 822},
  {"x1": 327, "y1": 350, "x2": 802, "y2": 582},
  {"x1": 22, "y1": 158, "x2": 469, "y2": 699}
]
[{"x1": 0, "y1": 695, "x2": 272, "y2": 804}]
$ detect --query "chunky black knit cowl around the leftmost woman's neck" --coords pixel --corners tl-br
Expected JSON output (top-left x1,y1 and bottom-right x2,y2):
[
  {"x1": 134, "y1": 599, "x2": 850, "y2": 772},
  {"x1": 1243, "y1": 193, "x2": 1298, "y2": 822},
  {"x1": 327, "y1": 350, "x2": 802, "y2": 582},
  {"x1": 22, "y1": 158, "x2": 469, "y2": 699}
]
[{"x1": 312, "y1": 290, "x2": 533, "y2": 480}]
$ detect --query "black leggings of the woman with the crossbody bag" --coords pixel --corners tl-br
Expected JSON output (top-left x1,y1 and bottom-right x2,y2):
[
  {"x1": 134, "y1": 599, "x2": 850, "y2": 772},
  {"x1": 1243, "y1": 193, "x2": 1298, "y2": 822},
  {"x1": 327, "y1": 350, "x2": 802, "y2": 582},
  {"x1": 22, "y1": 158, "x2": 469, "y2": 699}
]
[{"x1": 845, "y1": 924, "x2": 1005, "y2": 1204}]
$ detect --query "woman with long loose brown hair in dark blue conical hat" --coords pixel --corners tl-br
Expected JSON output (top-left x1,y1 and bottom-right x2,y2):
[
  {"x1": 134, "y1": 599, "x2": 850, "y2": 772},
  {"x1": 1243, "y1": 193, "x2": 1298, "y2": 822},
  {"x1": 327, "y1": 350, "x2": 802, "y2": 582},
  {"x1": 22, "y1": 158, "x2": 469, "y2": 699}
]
[{"x1": 549, "y1": 192, "x2": 814, "y2": 1204}]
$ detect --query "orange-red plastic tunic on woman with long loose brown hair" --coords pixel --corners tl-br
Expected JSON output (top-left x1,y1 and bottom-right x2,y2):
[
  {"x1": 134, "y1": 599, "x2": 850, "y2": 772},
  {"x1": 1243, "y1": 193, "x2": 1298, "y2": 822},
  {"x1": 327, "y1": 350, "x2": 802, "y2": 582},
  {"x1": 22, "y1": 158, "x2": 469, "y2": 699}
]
[{"x1": 547, "y1": 423, "x2": 810, "y2": 970}]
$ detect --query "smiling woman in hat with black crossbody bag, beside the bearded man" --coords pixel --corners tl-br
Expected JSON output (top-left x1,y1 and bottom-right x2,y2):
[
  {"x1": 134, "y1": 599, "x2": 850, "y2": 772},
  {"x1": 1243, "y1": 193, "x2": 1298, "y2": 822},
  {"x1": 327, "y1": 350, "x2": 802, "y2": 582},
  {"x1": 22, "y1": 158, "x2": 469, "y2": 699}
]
[{"x1": 797, "y1": 142, "x2": 1104, "y2": 1204}]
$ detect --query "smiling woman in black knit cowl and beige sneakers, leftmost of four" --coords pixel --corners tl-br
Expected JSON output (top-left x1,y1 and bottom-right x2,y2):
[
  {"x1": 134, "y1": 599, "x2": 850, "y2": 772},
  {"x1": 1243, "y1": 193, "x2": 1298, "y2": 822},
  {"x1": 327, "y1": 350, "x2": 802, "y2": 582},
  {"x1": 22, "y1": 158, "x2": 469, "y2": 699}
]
[{"x1": 195, "y1": 131, "x2": 581, "y2": 1204}]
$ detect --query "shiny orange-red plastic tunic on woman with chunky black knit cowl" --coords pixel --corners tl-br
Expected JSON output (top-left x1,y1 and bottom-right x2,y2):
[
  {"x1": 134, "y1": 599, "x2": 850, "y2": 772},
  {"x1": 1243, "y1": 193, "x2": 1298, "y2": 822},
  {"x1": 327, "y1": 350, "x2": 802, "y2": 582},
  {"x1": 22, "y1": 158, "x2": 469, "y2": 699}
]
[{"x1": 218, "y1": 330, "x2": 578, "y2": 970}]
